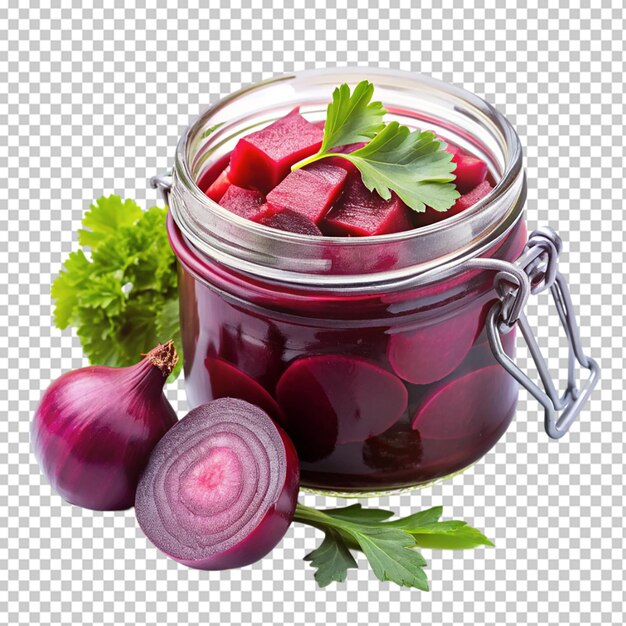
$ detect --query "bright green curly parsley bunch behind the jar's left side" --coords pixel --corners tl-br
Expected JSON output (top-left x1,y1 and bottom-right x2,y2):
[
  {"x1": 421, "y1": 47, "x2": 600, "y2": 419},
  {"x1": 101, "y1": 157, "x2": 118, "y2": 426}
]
[{"x1": 51, "y1": 196, "x2": 182, "y2": 377}]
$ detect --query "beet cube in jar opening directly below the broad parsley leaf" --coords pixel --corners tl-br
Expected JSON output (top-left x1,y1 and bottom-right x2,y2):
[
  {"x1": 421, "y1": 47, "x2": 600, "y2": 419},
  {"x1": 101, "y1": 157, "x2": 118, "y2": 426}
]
[{"x1": 323, "y1": 176, "x2": 413, "y2": 237}]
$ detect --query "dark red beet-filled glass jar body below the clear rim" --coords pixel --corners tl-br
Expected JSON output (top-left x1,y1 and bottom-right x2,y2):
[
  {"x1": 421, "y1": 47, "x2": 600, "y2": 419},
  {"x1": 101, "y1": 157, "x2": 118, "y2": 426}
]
[{"x1": 169, "y1": 214, "x2": 526, "y2": 493}]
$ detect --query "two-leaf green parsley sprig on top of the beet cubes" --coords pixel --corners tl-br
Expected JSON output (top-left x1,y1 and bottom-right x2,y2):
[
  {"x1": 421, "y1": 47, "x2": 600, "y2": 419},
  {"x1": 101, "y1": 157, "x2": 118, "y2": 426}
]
[{"x1": 292, "y1": 81, "x2": 460, "y2": 212}]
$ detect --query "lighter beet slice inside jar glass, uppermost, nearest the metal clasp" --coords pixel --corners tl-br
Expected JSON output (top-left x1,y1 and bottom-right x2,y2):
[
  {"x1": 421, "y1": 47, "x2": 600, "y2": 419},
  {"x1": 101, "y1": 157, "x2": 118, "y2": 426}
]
[{"x1": 387, "y1": 310, "x2": 479, "y2": 385}]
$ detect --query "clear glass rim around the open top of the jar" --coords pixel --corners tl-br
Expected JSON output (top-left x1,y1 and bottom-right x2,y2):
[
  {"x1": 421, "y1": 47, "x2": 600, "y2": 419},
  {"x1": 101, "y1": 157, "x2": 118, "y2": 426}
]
[{"x1": 170, "y1": 67, "x2": 525, "y2": 286}]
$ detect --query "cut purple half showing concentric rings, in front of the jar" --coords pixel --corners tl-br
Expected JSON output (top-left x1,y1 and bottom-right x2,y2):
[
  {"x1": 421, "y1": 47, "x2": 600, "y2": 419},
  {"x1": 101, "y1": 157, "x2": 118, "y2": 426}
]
[{"x1": 135, "y1": 399, "x2": 299, "y2": 570}]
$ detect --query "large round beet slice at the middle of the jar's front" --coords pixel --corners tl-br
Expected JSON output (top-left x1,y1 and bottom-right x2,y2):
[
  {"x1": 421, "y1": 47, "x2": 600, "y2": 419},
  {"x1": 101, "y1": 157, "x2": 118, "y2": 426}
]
[{"x1": 276, "y1": 354, "x2": 407, "y2": 461}]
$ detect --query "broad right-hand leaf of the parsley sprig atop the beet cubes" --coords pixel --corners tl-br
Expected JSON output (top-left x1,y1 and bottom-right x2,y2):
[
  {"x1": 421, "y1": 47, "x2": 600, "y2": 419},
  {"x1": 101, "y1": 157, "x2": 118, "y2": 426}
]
[{"x1": 336, "y1": 122, "x2": 461, "y2": 212}]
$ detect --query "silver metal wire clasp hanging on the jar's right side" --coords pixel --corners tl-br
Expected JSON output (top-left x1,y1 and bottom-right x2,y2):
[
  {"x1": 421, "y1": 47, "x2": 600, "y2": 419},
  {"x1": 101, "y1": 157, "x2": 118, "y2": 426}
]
[{"x1": 465, "y1": 227, "x2": 600, "y2": 439}]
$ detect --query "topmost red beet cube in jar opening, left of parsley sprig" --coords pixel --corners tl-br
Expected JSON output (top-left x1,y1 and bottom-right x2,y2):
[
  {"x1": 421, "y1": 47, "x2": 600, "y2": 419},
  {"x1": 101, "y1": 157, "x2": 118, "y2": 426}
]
[{"x1": 228, "y1": 107, "x2": 324, "y2": 193}]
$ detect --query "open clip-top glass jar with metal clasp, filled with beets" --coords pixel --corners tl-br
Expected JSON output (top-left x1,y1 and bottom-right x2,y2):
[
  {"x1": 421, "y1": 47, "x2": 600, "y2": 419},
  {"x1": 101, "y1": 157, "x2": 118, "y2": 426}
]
[{"x1": 153, "y1": 68, "x2": 597, "y2": 494}]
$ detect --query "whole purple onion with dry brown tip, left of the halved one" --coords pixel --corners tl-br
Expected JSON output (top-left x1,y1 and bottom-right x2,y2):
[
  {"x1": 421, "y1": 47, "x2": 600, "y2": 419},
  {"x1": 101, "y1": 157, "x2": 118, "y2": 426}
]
[{"x1": 31, "y1": 342, "x2": 178, "y2": 511}]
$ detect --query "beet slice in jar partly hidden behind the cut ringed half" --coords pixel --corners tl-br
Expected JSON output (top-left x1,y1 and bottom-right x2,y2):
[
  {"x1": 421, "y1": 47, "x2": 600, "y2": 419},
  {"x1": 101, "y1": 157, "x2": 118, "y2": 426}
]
[{"x1": 204, "y1": 356, "x2": 284, "y2": 421}]
